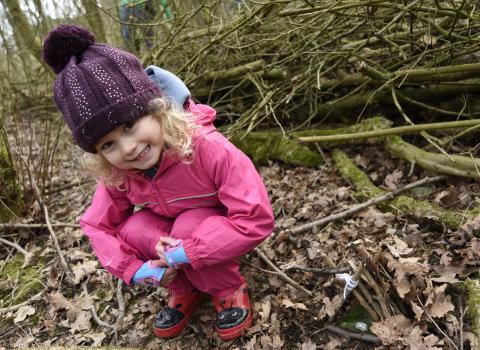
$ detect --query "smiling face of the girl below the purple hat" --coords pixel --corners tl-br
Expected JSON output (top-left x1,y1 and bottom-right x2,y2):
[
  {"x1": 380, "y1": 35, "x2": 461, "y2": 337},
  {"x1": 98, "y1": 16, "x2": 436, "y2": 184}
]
[{"x1": 95, "y1": 115, "x2": 165, "y2": 170}]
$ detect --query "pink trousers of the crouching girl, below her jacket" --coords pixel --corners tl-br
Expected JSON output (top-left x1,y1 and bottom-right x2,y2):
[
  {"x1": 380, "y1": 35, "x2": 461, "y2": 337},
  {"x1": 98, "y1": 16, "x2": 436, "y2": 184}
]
[{"x1": 119, "y1": 208, "x2": 244, "y2": 296}]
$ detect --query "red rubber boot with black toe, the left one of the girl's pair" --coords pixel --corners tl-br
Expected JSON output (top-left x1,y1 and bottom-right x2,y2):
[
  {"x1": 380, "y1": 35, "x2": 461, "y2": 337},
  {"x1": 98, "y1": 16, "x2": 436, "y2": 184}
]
[{"x1": 154, "y1": 291, "x2": 203, "y2": 338}]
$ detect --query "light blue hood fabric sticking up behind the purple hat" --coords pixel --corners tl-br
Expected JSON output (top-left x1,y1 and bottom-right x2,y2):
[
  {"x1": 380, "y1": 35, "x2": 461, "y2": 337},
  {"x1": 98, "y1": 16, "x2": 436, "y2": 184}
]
[{"x1": 145, "y1": 66, "x2": 190, "y2": 108}]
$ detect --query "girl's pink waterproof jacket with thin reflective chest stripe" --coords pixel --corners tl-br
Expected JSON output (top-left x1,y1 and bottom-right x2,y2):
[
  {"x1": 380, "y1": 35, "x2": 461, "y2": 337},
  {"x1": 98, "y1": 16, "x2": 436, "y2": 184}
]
[{"x1": 80, "y1": 102, "x2": 274, "y2": 284}]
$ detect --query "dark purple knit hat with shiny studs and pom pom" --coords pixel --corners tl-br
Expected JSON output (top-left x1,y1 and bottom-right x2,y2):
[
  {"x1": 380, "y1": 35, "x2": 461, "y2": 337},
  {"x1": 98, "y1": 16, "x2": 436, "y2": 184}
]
[{"x1": 43, "y1": 24, "x2": 163, "y2": 153}]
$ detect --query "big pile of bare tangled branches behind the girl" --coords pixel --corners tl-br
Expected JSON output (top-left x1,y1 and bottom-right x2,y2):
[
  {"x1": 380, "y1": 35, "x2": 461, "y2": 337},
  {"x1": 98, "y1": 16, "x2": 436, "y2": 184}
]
[{"x1": 148, "y1": 0, "x2": 480, "y2": 135}]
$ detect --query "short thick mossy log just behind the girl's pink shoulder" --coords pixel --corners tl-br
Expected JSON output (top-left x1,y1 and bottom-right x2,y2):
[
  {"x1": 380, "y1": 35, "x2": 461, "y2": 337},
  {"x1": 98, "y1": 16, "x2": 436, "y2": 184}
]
[{"x1": 230, "y1": 131, "x2": 324, "y2": 167}]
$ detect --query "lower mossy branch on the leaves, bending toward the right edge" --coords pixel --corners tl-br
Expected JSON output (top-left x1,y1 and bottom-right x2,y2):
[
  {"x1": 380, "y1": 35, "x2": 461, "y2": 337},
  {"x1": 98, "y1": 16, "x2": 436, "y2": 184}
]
[{"x1": 332, "y1": 149, "x2": 480, "y2": 230}]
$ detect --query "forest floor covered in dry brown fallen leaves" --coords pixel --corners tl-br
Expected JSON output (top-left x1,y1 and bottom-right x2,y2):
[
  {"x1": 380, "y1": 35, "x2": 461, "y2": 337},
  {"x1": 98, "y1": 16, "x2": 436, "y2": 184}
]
[{"x1": 0, "y1": 116, "x2": 480, "y2": 350}]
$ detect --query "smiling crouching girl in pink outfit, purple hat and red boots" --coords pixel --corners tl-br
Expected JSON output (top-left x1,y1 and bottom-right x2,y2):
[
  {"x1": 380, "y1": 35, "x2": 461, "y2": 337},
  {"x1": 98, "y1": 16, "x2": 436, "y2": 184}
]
[{"x1": 43, "y1": 25, "x2": 274, "y2": 340}]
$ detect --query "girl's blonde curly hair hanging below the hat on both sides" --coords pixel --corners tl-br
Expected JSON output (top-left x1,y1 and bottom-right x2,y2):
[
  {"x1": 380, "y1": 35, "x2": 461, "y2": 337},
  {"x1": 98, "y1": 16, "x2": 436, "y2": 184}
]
[{"x1": 84, "y1": 97, "x2": 198, "y2": 187}]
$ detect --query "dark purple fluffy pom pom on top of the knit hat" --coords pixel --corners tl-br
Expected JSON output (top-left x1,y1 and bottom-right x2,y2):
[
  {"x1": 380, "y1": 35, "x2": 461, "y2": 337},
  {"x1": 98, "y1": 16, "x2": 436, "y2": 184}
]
[{"x1": 43, "y1": 24, "x2": 95, "y2": 74}]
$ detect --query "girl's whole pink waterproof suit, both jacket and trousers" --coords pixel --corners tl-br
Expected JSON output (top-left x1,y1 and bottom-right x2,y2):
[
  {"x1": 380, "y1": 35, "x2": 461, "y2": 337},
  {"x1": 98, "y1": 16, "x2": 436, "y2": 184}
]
[{"x1": 80, "y1": 102, "x2": 274, "y2": 294}]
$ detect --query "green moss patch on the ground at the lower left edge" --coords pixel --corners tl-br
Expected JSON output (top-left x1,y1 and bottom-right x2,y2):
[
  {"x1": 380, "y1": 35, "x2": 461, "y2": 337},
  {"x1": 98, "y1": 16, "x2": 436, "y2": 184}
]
[{"x1": 0, "y1": 253, "x2": 43, "y2": 306}]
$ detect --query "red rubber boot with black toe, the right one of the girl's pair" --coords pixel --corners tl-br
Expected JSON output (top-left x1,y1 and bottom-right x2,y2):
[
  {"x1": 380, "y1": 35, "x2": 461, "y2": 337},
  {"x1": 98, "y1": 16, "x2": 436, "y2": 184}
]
[{"x1": 213, "y1": 282, "x2": 253, "y2": 340}]
